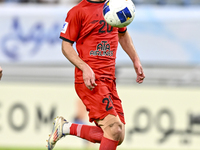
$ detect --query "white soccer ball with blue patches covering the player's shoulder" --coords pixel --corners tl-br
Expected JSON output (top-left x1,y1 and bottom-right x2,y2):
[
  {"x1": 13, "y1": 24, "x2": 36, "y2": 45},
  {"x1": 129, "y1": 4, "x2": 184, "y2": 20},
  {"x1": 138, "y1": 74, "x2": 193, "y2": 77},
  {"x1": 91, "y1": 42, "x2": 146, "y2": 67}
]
[{"x1": 103, "y1": 0, "x2": 135, "y2": 28}]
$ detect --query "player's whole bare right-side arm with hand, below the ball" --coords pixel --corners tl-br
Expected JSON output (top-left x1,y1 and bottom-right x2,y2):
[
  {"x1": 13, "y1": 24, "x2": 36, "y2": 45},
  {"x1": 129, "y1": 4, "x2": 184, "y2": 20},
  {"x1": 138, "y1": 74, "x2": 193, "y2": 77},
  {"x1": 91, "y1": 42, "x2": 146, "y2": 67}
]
[{"x1": 118, "y1": 31, "x2": 145, "y2": 83}]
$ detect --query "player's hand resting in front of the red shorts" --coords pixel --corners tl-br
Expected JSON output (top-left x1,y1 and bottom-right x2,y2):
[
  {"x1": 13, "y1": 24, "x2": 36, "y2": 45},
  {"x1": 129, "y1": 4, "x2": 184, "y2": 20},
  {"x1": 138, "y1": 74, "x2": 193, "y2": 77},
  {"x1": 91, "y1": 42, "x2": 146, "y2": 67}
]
[{"x1": 83, "y1": 65, "x2": 97, "y2": 91}]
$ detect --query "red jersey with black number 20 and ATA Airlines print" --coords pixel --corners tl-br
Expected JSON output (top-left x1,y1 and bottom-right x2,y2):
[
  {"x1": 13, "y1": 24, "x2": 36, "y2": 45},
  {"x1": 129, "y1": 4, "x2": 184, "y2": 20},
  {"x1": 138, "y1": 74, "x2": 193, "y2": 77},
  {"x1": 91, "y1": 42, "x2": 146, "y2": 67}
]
[{"x1": 60, "y1": 0, "x2": 126, "y2": 83}]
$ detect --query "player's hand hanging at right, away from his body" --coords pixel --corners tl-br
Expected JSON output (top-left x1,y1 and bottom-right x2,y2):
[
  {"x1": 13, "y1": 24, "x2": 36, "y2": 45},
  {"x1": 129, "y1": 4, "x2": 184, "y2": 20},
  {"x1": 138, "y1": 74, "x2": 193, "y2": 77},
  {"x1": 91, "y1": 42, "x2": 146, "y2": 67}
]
[{"x1": 134, "y1": 62, "x2": 145, "y2": 83}]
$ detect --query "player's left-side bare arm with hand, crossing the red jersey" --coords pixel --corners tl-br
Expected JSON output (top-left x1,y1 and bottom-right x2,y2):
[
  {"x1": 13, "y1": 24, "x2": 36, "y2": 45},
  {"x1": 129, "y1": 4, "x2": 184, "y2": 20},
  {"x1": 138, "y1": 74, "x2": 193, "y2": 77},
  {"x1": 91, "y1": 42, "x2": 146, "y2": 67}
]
[{"x1": 62, "y1": 40, "x2": 97, "y2": 90}]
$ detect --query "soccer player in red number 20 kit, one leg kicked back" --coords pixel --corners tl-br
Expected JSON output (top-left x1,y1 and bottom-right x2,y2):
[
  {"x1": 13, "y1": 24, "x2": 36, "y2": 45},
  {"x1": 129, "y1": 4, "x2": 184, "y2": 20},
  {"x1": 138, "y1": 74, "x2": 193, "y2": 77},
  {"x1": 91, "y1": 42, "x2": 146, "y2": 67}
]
[{"x1": 47, "y1": 0, "x2": 145, "y2": 150}]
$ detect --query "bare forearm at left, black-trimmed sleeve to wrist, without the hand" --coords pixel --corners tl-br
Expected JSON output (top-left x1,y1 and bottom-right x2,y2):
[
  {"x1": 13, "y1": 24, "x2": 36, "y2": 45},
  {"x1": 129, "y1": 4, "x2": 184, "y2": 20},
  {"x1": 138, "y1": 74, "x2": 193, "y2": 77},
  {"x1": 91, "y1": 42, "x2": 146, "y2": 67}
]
[{"x1": 62, "y1": 41, "x2": 87, "y2": 71}]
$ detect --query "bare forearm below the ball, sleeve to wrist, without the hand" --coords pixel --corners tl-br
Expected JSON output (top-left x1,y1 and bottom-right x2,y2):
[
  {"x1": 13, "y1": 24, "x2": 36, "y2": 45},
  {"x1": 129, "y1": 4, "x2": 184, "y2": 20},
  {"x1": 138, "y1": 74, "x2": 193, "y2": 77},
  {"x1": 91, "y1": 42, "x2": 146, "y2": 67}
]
[{"x1": 119, "y1": 32, "x2": 139, "y2": 63}]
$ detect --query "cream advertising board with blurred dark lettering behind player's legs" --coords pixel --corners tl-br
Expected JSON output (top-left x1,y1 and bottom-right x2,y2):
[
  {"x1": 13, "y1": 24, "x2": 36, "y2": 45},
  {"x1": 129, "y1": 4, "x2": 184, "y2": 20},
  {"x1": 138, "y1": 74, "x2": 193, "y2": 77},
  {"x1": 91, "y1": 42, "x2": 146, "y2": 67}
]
[{"x1": 0, "y1": 83, "x2": 200, "y2": 150}]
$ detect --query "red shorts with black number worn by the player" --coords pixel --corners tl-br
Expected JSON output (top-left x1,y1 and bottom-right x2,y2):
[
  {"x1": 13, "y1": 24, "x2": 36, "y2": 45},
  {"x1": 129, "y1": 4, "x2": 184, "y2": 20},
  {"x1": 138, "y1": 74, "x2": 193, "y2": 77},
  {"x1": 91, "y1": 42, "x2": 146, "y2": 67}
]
[{"x1": 75, "y1": 78, "x2": 125, "y2": 124}]
